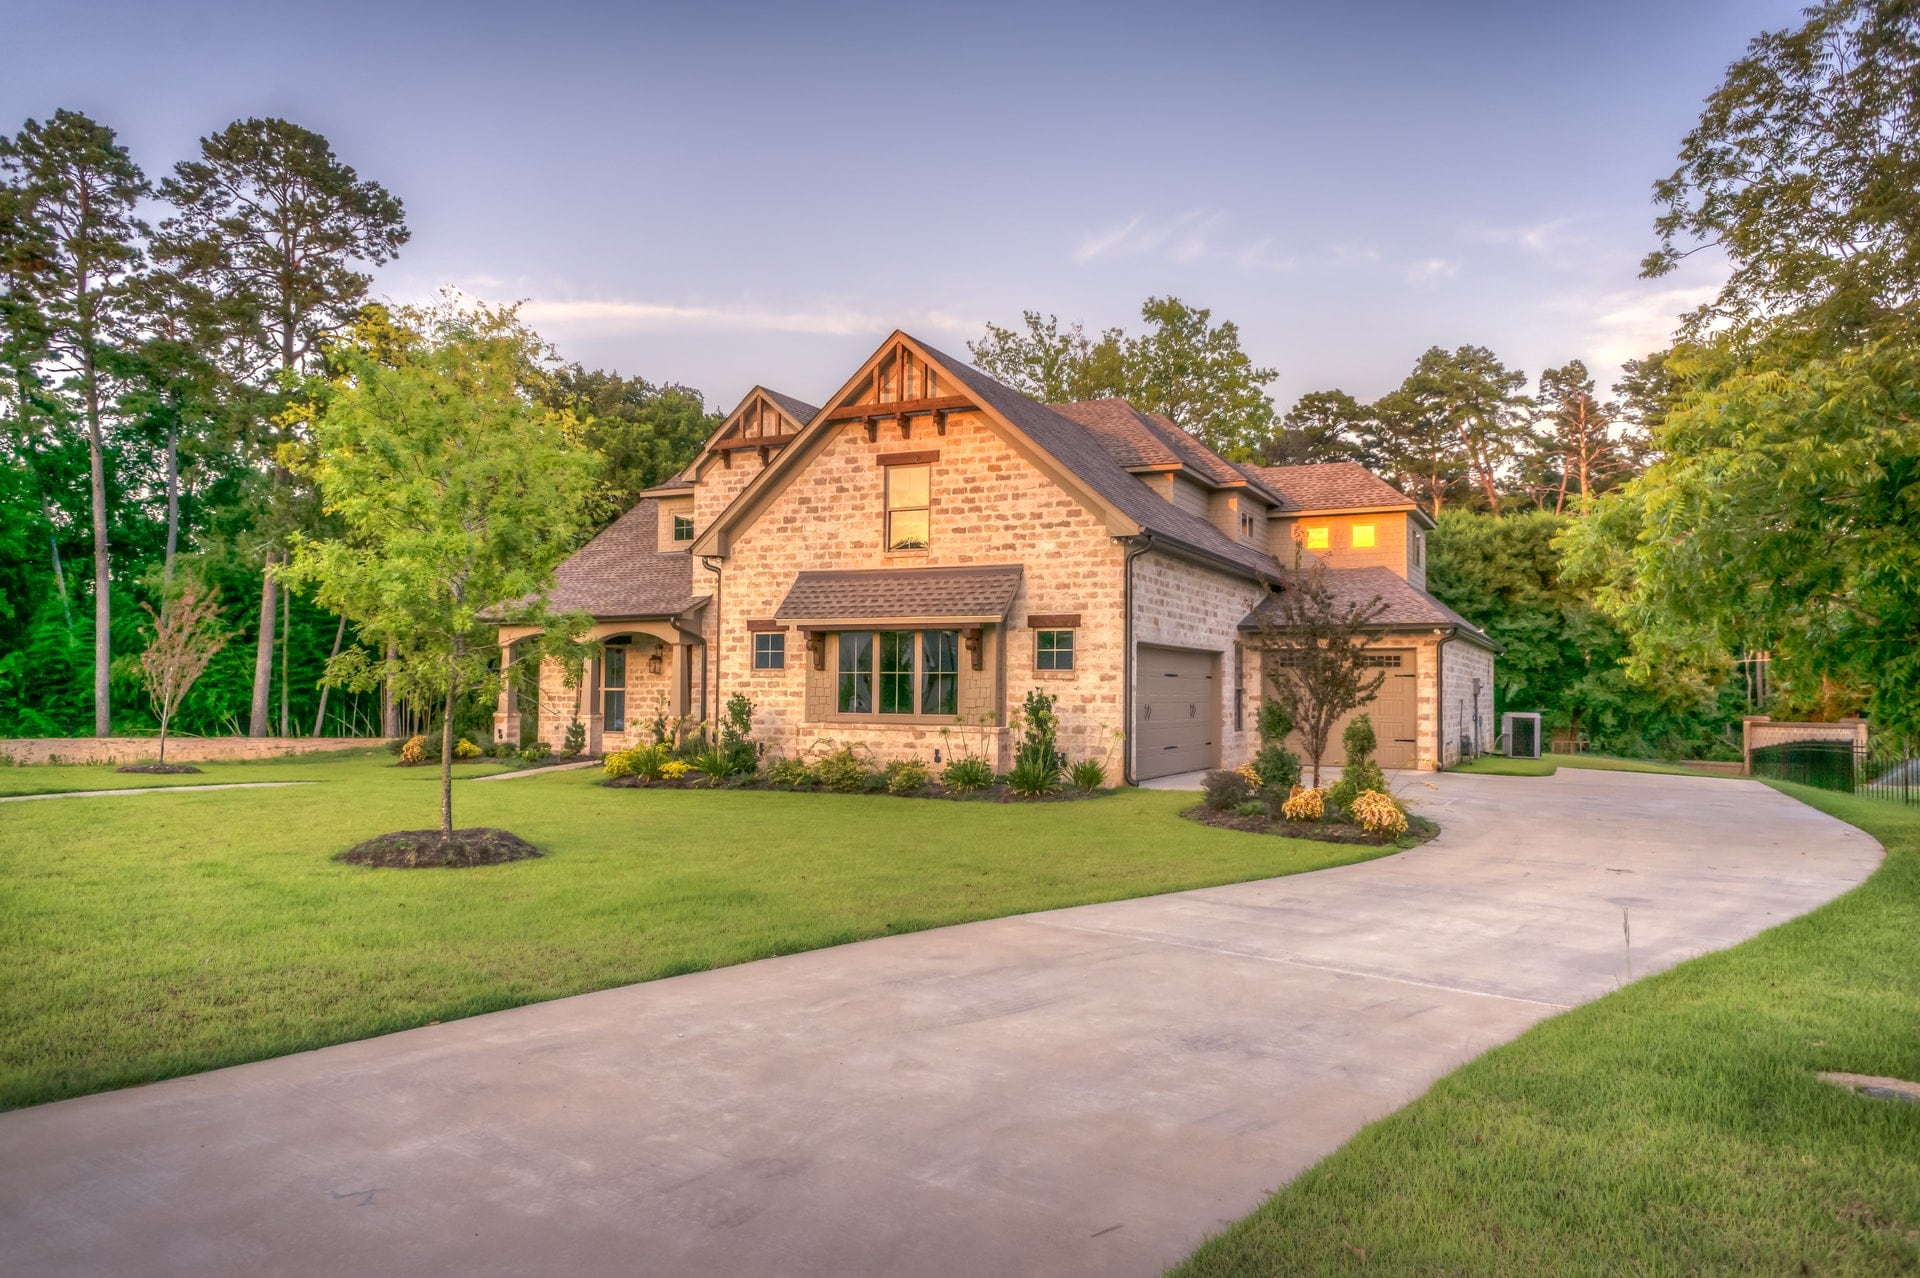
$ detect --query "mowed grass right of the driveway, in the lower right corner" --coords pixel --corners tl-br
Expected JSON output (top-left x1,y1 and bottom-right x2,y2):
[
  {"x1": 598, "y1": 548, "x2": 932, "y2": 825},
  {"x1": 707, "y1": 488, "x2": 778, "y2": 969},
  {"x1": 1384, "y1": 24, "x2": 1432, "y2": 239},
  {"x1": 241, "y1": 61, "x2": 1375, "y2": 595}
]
[{"x1": 1175, "y1": 785, "x2": 1920, "y2": 1276}]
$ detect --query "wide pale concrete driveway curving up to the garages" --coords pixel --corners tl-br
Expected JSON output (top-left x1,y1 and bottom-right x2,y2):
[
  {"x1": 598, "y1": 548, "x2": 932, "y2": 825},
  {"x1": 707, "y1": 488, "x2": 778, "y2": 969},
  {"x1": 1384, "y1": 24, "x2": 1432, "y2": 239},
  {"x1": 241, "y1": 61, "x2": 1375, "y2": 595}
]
[{"x1": 0, "y1": 771, "x2": 1880, "y2": 1278}]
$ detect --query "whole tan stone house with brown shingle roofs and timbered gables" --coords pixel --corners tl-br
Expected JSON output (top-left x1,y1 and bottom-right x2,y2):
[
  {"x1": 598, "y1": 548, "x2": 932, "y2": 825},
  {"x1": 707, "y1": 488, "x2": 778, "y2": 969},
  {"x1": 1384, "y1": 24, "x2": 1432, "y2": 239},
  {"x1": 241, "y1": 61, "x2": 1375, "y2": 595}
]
[{"x1": 495, "y1": 332, "x2": 1496, "y2": 781}]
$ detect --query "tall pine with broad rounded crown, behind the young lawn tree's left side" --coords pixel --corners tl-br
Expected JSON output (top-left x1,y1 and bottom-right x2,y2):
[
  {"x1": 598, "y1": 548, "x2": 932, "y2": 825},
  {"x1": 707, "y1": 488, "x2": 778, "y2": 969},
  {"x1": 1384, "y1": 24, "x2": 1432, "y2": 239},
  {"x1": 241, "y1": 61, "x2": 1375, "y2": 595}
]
[{"x1": 154, "y1": 119, "x2": 409, "y2": 737}]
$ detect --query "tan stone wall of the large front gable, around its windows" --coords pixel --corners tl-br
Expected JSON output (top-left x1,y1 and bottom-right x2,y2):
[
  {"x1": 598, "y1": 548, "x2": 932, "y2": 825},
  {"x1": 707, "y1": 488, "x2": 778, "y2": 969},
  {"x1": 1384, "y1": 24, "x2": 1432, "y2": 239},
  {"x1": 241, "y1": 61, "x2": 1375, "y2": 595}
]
[{"x1": 703, "y1": 413, "x2": 1123, "y2": 773}]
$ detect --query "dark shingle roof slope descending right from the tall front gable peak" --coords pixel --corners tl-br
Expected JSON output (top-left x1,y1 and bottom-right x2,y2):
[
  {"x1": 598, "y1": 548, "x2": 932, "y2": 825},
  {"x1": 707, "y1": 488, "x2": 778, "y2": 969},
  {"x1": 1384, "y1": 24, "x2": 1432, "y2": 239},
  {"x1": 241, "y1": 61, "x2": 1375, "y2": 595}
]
[{"x1": 916, "y1": 338, "x2": 1279, "y2": 578}]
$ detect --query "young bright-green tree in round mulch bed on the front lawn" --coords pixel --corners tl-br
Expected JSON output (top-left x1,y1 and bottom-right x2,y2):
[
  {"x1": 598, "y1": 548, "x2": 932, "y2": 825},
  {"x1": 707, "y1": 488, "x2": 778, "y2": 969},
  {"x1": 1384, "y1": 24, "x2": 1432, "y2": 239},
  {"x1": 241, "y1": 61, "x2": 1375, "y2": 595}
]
[{"x1": 284, "y1": 297, "x2": 593, "y2": 839}]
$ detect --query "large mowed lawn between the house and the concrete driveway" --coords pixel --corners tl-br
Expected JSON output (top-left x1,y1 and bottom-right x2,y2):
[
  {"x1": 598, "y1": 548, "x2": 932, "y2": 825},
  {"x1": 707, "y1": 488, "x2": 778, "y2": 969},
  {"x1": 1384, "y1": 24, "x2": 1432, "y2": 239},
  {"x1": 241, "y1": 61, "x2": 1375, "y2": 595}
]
[{"x1": 0, "y1": 754, "x2": 1392, "y2": 1107}]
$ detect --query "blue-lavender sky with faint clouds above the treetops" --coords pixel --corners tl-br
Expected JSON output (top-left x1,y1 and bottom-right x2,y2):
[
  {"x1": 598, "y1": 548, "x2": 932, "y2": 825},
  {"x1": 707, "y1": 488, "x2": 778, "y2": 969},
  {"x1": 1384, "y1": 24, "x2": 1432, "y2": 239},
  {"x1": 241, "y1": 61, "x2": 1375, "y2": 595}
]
[{"x1": 0, "y1": 0, "x2": 1799, "y2": 409}]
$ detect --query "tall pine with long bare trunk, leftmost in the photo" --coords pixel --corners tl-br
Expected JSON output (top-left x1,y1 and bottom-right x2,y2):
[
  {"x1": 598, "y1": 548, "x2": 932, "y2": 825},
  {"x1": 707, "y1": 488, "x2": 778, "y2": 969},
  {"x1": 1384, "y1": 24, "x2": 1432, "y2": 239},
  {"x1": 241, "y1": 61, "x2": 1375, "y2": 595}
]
[{"x1": 0, "y1": 111, "x2": 148, "y2": 737}]
